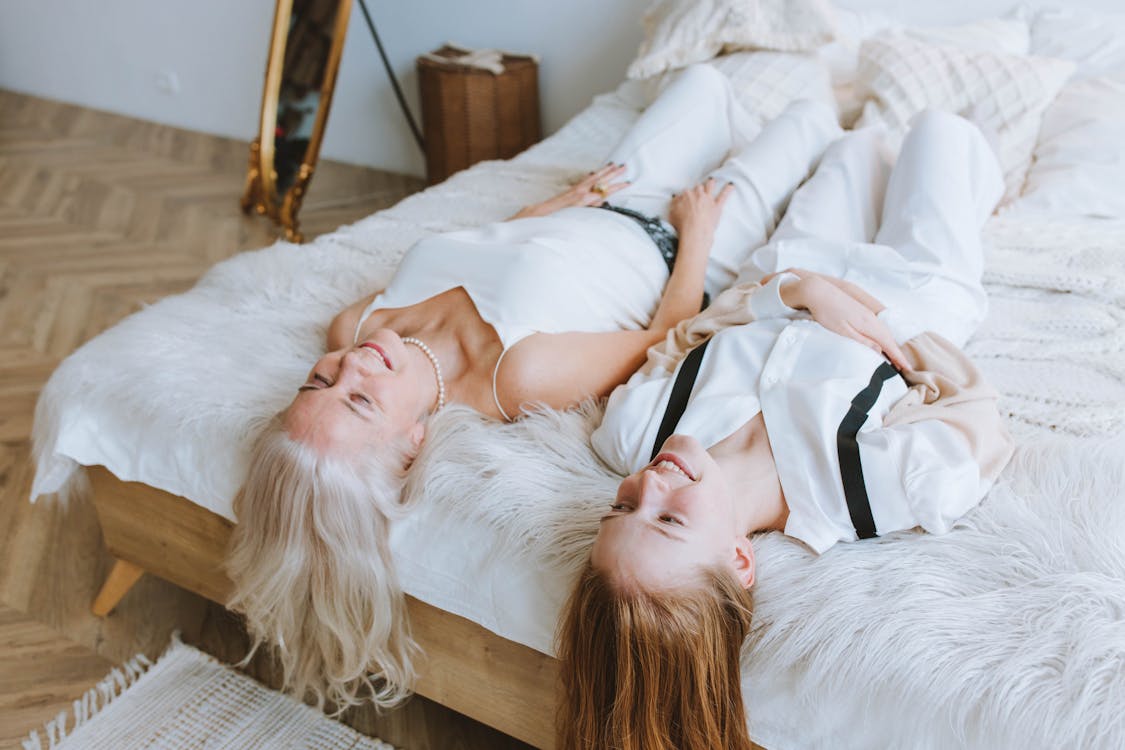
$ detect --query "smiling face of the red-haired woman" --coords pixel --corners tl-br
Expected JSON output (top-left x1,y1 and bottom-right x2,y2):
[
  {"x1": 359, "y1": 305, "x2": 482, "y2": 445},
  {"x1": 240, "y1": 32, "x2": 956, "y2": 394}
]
[{"x1": 591, "y1": 435, "x2": 754, "y2": 590}]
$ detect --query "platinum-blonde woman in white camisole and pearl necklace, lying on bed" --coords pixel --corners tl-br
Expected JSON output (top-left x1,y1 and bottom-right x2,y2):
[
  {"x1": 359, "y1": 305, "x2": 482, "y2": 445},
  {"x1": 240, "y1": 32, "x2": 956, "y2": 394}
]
[{"x1": 227, "y1": 66, "x2": 838, "y2": 710}]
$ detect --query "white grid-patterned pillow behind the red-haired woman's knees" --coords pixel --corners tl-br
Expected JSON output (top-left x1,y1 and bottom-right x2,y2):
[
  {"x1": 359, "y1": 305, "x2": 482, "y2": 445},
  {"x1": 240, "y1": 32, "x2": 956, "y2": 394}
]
[{"x1": 857, "y1": 34, "x2": 1074, "y2": 199}]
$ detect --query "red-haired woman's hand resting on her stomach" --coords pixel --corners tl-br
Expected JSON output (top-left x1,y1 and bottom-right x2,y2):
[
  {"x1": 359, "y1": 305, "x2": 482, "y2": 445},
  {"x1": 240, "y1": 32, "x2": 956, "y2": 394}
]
[{"x1": 778, "y1": 269, "x2": 911, "y2": 370}]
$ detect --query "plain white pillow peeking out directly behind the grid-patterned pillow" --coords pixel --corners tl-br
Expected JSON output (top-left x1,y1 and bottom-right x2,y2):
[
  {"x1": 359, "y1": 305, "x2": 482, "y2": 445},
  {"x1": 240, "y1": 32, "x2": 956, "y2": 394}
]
[{"x1": 817, "y1": 16, "x2": 1031, "y2": 126}]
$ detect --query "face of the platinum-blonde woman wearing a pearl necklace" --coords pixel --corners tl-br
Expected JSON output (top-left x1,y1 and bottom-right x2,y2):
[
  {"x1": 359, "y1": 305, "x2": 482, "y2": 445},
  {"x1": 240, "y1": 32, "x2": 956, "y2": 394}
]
[{"x1": 284, "y1": 328, "x2": 433, "y2": 455}]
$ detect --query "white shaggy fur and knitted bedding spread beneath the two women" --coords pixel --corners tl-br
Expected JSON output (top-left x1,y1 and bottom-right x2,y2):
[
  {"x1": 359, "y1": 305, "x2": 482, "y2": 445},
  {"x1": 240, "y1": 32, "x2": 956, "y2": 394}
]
[{"x1": 33, "y1": 76, "x2": 1125, "y2": 748}]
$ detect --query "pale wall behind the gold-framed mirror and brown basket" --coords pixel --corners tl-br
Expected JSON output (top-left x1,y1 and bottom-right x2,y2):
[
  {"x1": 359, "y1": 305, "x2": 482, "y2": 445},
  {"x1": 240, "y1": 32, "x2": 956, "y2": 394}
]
[{"x1": 0, "y1": 0, "x2": 647, "y2": 174}]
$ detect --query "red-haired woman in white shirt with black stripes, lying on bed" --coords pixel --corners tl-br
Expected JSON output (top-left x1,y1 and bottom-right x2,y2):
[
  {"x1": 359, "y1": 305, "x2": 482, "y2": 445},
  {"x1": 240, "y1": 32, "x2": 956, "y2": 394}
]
[{"x1": 559, "y1": 112, "x2": 1011, "y2": 750}]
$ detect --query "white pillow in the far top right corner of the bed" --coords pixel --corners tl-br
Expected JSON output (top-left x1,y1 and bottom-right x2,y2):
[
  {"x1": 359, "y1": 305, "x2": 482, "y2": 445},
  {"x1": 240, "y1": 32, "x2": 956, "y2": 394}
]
[{"x1": 1017, "y1": 6, "x2": 1125, "y2": 78}]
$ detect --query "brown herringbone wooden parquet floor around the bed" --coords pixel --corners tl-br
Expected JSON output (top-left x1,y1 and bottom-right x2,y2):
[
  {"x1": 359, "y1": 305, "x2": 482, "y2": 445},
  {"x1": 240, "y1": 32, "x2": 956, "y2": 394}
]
[{"x1": 0, "y1": 91, "x2": 527, "y2": 750}]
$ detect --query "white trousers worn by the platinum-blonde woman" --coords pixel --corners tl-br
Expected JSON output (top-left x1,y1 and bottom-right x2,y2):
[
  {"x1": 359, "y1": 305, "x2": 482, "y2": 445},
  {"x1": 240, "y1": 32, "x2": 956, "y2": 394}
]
[{"x1": 608, "y1": 65, "x2": 840, "y2": 296}]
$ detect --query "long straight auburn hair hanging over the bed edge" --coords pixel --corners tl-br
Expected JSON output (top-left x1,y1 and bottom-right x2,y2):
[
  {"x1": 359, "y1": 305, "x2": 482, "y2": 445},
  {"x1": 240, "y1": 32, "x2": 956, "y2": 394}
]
[{"x1": 557, "y1": 562, "x2": 754, "y2": 750}]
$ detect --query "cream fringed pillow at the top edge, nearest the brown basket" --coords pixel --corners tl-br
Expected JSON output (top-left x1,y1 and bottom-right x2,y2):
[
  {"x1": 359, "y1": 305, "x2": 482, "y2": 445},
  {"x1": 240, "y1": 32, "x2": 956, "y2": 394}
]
[{"x1": 627, "y1": 0, "x2": 833, "y2": 79}]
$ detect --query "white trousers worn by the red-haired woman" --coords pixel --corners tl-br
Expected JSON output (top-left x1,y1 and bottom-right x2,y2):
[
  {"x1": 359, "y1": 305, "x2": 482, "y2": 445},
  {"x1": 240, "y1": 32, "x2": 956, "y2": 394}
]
[{"x1": 739, "y1": 111, "x2": 1004, "y2": 346}]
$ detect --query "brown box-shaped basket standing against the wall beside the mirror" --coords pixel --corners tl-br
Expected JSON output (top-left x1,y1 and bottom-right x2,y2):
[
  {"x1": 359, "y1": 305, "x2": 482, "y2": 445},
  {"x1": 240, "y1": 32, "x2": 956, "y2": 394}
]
[{"x1": 417, "y1": 45, "x2": 540, "y2": 184}]
